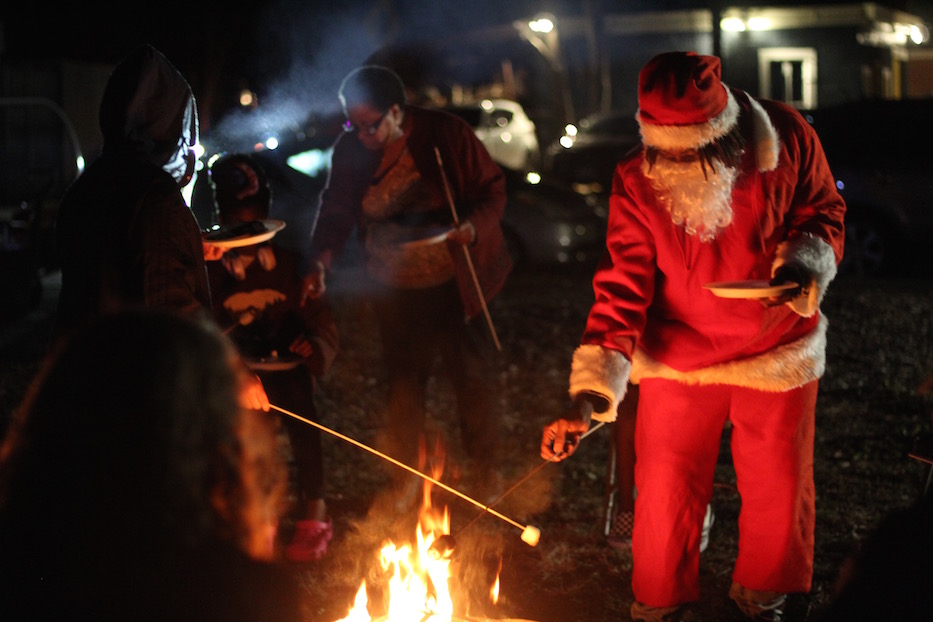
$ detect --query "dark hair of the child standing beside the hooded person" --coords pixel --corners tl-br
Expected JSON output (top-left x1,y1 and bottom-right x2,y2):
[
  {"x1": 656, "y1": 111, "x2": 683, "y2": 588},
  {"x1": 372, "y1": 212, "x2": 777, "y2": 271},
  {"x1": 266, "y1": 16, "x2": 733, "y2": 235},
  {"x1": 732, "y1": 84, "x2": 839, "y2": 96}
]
[{"x1": 208, "y1": 154, "x2": 272, "y2": 222}]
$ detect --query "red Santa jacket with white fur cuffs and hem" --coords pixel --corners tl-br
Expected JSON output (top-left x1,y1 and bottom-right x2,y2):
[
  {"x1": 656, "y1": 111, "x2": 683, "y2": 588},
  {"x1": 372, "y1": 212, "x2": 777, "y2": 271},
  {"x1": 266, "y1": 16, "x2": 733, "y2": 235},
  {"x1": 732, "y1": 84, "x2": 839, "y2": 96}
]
[{"x1": 570, "y1": 89, "x2": 845, "y2": 420}]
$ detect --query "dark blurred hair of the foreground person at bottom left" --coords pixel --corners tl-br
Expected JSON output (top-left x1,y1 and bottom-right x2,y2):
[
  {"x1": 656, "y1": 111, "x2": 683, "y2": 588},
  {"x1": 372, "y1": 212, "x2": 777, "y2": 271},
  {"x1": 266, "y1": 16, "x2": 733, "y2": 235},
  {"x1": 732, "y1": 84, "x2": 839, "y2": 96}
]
[{"x1": 0, "y1": 309, "x2": 282, "y2": 576}]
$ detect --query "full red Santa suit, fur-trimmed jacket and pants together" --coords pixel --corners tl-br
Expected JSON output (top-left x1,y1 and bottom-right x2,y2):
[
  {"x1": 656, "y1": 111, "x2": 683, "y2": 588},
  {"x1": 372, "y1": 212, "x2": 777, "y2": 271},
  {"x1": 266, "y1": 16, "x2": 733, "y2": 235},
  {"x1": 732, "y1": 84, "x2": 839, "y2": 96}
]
[{"x1": 570, "y1": 89, "x2": 845, "y2": 607}]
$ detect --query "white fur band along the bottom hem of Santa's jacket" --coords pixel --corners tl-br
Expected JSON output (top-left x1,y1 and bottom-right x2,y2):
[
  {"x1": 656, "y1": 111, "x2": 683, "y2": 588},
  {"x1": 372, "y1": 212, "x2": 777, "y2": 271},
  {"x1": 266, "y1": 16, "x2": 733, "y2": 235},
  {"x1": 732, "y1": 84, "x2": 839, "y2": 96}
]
[{"x1": 631, "y1": 316, "x2": 828, "y2": 393}]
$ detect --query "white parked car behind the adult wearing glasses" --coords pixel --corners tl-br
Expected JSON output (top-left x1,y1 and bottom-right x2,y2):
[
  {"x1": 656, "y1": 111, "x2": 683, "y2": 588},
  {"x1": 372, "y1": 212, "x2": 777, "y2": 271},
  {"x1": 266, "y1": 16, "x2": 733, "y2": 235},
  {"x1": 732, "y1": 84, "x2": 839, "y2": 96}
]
[{"x1": 445, "y1": 99, "x2": 541, "y2": 171}]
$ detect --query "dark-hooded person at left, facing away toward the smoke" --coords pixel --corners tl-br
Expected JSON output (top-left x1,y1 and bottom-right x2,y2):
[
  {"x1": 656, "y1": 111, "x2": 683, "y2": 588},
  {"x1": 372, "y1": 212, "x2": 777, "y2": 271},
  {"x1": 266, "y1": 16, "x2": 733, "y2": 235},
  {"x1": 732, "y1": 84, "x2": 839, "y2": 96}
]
[{"x1": 56, "y1": 46, "x2": 210, "y2": 344}]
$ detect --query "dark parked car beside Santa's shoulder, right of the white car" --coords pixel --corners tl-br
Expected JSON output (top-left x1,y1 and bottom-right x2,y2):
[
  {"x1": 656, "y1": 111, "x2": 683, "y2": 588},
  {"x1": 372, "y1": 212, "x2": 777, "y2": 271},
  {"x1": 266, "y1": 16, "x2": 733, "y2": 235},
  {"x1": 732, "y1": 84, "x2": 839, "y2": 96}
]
[{"x1": 543, "y1": 111, "x2": 641, "y2": 195}]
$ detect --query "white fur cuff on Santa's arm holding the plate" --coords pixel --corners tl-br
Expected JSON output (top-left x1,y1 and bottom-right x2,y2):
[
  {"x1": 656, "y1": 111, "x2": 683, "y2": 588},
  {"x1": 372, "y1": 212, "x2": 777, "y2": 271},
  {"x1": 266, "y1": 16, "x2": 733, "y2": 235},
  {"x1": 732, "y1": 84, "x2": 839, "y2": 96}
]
[{"x1": 771, "y1": 233, "x2": 836, "y2": 317}]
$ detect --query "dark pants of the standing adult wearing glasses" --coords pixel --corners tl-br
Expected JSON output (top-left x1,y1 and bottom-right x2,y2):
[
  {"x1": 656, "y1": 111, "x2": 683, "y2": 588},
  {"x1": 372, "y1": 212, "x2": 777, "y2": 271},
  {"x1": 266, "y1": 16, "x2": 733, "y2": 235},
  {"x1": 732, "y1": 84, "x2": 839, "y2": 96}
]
[{"x1": 374, "y1": 281, "x2": 499, "y2": 468}]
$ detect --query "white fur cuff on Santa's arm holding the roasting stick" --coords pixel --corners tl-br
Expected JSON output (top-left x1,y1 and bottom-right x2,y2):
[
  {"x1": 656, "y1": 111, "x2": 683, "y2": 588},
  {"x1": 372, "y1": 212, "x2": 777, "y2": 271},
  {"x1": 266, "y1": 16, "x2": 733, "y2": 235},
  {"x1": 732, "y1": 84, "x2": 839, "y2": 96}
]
[{"x1": 570, "y1": 344, "x2": 632, "y2": 423}]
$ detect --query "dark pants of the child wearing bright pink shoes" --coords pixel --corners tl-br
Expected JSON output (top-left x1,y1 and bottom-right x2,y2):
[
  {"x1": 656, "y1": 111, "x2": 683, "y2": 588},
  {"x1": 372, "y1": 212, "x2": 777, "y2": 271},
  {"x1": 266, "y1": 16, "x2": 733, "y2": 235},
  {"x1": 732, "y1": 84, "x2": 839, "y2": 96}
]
[{"x1": 259, "y1": 365, "x2": 324, "y2": 501}]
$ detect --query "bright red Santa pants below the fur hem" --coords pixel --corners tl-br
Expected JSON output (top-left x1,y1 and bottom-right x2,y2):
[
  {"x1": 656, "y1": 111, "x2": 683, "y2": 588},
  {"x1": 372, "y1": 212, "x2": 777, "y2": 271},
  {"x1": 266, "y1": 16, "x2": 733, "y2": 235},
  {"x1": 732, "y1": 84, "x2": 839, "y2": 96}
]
[{"x1": 632, "y1": 378, "x2": 818, "y2": 607}]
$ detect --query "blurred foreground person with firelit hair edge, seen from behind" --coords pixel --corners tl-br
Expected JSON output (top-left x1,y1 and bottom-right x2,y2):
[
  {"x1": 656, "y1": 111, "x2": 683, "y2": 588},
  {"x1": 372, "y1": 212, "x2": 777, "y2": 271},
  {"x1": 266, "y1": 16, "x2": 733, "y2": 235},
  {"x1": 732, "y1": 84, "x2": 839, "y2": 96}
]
[{"x1": 0, "y1": 309, "x2": 299, "y2": 620}]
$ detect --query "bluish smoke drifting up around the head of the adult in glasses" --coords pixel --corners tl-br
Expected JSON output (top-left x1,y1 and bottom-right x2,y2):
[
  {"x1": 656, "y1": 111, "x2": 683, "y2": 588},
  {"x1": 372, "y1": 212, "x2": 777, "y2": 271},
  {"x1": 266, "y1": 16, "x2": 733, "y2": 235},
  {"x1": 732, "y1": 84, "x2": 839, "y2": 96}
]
[{"x1": 204, "y1": 0, "x2": 540, "y2": 148}]
